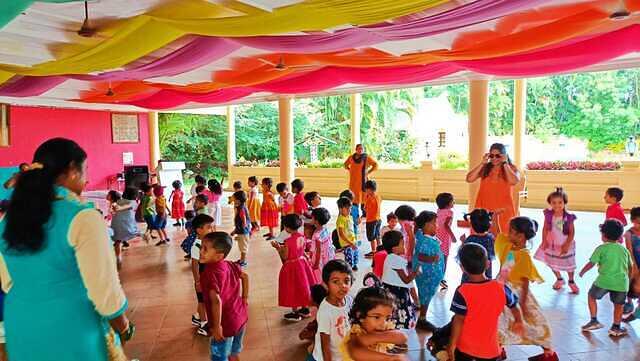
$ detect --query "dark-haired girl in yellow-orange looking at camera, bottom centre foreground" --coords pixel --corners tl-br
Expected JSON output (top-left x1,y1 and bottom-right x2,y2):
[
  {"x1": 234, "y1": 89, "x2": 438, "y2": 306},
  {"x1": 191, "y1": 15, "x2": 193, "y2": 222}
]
[{"x1": 341, "y1": 286, "x2": 407, "y2": 361}]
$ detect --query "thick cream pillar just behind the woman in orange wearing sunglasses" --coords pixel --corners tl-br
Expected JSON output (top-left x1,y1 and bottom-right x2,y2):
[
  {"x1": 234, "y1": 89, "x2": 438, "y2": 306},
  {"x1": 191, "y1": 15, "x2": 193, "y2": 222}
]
[{"x1": 469, "y1": 80, "x2": 489, "y2": 209}]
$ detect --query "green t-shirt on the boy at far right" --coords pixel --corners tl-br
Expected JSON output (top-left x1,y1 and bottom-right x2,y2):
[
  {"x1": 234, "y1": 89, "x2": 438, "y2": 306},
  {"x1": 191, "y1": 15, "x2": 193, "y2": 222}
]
[{"x1": 589, "y1": 242, "x2": 631, "y2": 292}]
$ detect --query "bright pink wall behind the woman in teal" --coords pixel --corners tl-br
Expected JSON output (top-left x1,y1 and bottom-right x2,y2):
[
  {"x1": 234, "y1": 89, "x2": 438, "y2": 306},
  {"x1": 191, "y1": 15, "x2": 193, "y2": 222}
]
[{"x1": 0, "y1": 106, "x2": 149, "y2": 190}]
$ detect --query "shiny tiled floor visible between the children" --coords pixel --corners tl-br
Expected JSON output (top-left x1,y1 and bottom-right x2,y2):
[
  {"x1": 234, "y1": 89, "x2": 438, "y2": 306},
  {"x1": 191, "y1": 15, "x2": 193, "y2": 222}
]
[{"x1": 121, "y1": 198, "x2": 640, "y2": 361}]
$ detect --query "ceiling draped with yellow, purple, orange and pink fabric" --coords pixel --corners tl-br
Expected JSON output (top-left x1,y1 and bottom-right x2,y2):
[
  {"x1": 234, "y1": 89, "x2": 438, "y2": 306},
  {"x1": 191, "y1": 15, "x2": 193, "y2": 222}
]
[{"x1": 0, "y1": 0, "x2": 640, "y2": 111}]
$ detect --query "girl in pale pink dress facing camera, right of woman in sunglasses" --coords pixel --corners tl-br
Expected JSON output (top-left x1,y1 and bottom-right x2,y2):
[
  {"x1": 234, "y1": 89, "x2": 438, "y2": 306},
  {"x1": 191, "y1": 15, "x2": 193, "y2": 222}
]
[{"x1": 535, "y1": 188, "x2": 580, "y2": 294}]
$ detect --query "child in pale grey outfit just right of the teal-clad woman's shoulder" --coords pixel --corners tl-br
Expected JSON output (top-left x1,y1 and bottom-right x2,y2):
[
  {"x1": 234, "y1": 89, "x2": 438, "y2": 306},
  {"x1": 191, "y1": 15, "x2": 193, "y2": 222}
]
[{"x1": 111, "y1": 188, "x2": 139, "y2": 267}]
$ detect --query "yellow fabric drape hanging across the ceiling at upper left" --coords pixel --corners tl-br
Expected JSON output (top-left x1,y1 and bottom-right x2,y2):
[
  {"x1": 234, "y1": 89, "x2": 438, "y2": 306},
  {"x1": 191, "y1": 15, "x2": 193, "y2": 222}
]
[{"x1": 0, "y1": 0, "x2": 448, "y2": 81}]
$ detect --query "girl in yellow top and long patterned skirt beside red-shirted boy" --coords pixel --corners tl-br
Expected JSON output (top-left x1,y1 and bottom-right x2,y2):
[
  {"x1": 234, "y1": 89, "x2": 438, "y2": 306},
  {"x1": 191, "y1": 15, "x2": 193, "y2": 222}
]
[{"x1": 495, "y1": 217, "x2": 558, "y2": 361}]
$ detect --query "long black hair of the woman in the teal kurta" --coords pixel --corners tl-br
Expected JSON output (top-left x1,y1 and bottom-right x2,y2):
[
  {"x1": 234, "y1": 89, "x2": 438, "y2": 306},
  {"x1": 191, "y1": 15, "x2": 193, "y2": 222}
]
[{"x1": 2, "y1": 138, "x2": 87, "y2": 253}]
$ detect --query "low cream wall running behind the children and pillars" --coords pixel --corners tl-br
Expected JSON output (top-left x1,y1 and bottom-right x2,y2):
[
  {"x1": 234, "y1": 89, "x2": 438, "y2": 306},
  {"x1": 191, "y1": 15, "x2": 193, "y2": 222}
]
[{"x1": 229, "y1": 161, "x2": 640, "y2": 211}]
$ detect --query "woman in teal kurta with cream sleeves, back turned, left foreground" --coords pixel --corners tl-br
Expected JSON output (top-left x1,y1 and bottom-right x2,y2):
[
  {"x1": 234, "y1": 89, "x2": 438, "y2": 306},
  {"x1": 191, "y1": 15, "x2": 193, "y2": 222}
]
[{"x1": 0, "y1": 138, "x2": 133, "y2": 361}]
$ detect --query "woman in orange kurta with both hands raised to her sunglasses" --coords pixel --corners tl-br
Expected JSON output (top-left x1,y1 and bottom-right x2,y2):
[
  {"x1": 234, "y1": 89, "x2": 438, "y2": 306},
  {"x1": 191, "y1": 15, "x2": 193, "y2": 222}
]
[{"x1": 467, "y1": 143, "x2": 520, "y2": 234}]
